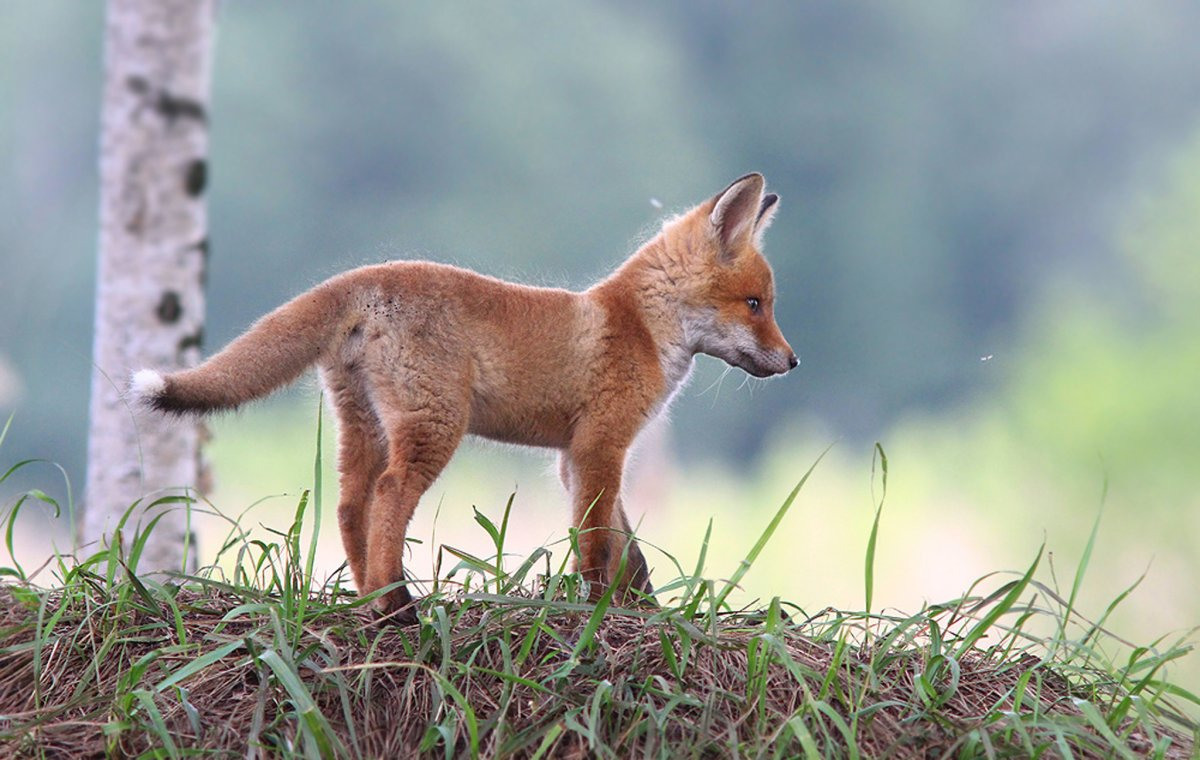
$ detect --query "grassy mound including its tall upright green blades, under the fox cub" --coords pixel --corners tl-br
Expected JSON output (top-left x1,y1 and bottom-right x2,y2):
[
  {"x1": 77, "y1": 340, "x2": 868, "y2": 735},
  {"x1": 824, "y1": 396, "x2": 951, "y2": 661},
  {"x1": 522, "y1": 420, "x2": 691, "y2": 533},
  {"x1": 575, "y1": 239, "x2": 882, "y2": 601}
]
[{"x1": 0, "y1": 417, "x2": 1200, "y2": 758}]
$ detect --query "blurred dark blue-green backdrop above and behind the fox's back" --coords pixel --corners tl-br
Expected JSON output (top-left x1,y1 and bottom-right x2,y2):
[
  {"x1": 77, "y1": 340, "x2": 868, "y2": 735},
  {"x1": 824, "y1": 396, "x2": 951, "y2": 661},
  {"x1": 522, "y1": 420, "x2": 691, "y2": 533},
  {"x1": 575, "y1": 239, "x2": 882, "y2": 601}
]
[{"x1": 0, "y1": 0, "x2": 1200, "y2": 492}]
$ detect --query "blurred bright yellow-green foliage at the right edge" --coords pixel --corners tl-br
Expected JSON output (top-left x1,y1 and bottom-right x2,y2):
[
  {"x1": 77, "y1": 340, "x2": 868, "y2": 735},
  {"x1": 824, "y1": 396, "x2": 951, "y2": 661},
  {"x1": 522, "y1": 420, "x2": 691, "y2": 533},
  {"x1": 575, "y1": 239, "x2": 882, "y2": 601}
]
[{"x1": 1004, "y1": 126, "x2": 1200, "y2": 497}]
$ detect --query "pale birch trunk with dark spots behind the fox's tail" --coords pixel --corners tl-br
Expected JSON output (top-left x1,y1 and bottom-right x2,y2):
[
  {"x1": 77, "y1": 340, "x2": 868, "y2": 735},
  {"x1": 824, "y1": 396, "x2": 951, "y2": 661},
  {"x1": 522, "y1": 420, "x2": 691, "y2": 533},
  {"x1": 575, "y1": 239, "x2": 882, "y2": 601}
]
[{"x1": 80, "y1": 0, "x2": 215, "y2": 570}]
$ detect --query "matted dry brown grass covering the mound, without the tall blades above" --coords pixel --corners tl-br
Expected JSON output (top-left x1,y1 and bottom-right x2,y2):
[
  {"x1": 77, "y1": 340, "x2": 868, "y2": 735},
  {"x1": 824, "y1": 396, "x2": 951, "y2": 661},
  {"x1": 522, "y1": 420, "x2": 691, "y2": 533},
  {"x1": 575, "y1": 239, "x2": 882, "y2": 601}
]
[{"x1": 0, "y1": 571, "x2": 1193, "y2": 758}]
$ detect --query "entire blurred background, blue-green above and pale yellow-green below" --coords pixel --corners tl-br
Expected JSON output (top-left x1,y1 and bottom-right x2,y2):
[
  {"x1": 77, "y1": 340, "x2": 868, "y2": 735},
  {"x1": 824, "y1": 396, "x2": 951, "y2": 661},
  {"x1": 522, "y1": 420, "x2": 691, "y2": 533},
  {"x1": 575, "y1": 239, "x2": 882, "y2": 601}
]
[{"x1": 0, "y1": 0, "x2": 1200, "y2": 688}]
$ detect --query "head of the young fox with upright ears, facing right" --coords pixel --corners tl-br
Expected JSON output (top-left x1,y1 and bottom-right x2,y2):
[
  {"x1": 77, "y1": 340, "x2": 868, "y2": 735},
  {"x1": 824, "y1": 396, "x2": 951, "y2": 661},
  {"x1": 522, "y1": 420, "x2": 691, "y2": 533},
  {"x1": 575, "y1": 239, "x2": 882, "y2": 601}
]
[{"x1": 665, "y1": 174, "x2": 799, "y2": 377}]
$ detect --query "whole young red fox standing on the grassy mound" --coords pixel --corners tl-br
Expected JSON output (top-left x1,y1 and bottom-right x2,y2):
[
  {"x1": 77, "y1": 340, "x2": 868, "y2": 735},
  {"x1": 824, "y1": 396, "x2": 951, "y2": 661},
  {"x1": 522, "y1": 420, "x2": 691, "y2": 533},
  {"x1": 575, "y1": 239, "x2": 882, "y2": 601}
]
[{"x1": 131, "y1": 174, "x2": 799, "y2": 623}]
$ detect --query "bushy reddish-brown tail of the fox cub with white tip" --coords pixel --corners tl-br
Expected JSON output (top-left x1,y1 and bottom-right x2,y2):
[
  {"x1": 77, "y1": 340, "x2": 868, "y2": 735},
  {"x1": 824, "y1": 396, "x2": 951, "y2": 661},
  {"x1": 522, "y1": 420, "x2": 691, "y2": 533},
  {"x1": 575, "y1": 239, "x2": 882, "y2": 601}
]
[{"x1": 130, "y1": 283, "x2": 346, "y2": 414}]
